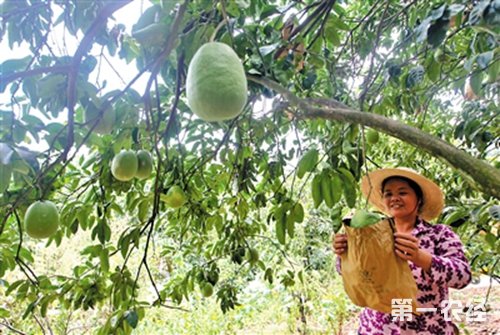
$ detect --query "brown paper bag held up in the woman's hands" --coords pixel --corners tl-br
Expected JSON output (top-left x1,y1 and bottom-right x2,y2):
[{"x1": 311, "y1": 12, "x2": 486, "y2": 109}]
[{"x1": 341, "y1": 219, "x2": 419, "y2": 314}]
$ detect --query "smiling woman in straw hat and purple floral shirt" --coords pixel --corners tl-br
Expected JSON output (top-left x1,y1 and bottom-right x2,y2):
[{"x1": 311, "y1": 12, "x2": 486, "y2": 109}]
[{"x1": 333, "y1": 168, "x2": 471, "y2": 335}]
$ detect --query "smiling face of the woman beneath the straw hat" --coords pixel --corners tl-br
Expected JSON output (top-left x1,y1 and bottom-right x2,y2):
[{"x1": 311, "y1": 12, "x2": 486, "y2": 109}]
[{"x1": 382, "y1": 179, "x2": 418, "y2": 219}]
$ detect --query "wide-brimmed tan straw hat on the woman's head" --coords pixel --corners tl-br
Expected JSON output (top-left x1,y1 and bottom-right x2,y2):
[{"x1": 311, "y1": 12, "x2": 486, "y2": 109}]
[{"x1": 361, "y1": 167, "x2": 444, "y2": 221}]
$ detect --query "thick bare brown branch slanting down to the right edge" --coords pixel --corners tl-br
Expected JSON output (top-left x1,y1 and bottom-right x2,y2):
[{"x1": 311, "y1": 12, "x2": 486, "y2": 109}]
[{"x1": 248, "y1": 76, "x2": 500, "y2": 199}]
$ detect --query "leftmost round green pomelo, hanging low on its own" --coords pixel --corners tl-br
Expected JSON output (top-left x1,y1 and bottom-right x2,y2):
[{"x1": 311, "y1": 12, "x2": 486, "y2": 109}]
[{"x1": 24, "y1": 200, "x2": 59, "y2": 238}]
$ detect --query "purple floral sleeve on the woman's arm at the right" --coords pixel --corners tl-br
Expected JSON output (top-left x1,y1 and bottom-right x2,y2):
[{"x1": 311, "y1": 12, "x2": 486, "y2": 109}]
[{"x1": 423, "y1": 225, "x2": 472, "y2": 289}]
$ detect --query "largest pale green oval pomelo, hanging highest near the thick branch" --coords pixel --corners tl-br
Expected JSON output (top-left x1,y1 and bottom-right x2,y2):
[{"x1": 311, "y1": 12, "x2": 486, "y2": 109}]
[{"x1": 186, "y1": 42, "x2": 247, "y2": 122}]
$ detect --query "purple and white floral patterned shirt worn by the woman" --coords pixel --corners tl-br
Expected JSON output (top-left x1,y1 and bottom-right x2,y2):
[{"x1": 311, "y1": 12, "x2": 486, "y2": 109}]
[{"x1": 337, "y1": 219, "x2": 472, "y2": 335}]
